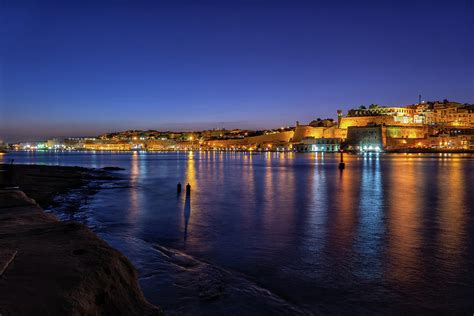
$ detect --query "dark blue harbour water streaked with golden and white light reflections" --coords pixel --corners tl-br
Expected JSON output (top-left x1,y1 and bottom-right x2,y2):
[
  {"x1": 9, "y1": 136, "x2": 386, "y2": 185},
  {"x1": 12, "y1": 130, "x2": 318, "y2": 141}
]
[{"x1": 4, "y1": 152, "x2": 474, "y2": 315}]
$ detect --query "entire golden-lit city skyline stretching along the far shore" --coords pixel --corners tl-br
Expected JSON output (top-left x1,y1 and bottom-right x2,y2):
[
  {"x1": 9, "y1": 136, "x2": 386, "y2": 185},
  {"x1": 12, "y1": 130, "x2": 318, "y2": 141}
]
[{"x1": 7, "y1": 100, "x2": 474, "y2": 152}]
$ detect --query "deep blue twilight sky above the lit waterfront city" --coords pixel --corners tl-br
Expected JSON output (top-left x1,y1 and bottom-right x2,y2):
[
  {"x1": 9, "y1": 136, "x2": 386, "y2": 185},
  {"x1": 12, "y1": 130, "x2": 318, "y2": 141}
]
[{"x1": 0, "y1": 0, "x2": 474, "y2": 140}]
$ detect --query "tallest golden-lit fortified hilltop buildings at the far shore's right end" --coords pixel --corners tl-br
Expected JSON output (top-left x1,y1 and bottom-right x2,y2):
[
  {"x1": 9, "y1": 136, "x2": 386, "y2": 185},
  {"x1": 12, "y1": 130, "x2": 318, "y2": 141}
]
[{"x1": 340, "y1": 100, "x2": 474, "y2": 151}]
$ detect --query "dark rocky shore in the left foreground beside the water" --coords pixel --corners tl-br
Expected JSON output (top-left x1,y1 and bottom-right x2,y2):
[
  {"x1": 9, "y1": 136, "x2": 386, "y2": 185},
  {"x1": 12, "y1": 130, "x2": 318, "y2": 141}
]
[{"x1": 0, "y1": 165, "x2": 162, "y2": 315}]
